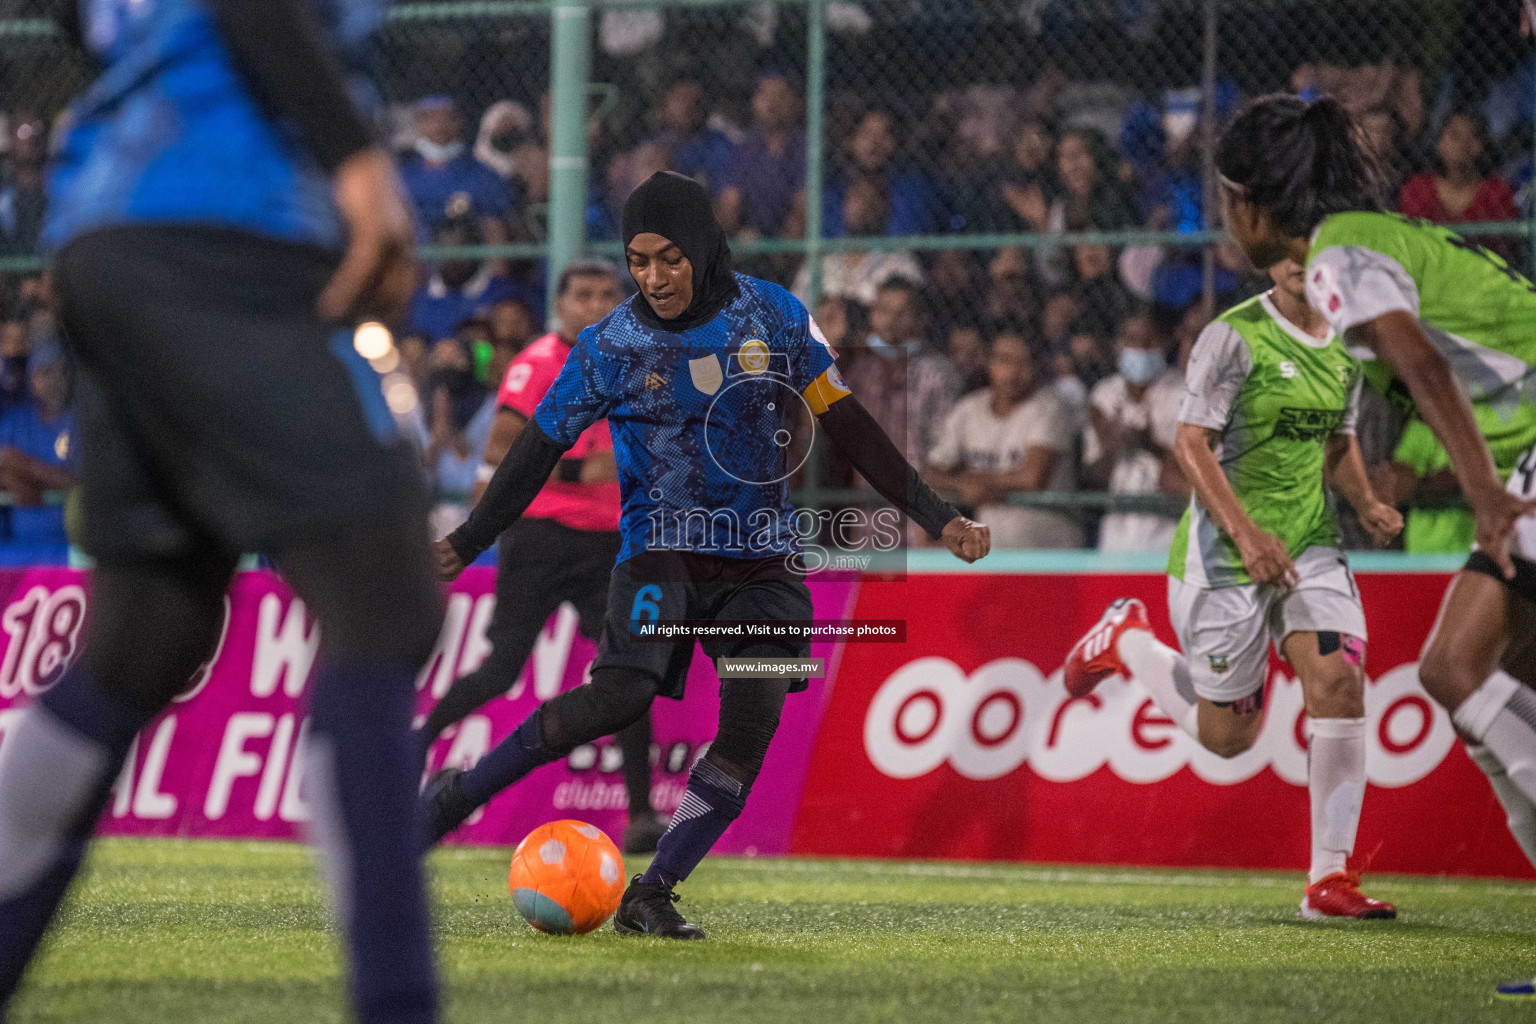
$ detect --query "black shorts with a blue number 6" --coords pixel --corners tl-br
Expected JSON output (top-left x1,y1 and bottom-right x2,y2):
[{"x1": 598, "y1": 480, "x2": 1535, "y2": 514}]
[{"x1": 591, "y1": 551, "x2": 811, "y2": 700}]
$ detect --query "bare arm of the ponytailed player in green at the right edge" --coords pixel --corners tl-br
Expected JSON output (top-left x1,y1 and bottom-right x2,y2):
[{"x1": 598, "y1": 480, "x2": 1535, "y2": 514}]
[{"x1": 1355, "y1": 310, "x2": 1536, "y2": 579}]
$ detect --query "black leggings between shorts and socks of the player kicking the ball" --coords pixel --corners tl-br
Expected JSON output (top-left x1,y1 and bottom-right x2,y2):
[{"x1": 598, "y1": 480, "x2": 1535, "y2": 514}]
[{"x1": 539, "y1": 648, "x2": 793, "y2": 788}]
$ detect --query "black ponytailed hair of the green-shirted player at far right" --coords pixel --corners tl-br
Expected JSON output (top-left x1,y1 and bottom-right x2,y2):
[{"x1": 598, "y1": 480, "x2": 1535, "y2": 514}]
[{"x1": 1217, "y1": 94, "x2": 1382, "y2": 238}]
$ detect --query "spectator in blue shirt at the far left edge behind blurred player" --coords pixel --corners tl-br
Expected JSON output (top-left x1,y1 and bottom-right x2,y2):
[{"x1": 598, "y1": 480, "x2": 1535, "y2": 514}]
[{"x1": 0, "y1": 339, "x2": 75, "y2": 560}]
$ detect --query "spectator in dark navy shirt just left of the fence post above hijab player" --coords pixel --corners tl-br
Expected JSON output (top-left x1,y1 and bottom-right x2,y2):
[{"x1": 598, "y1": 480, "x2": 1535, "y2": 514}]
[{"x1": 716, "y1": 72, "x2": 805, "y2": 238}]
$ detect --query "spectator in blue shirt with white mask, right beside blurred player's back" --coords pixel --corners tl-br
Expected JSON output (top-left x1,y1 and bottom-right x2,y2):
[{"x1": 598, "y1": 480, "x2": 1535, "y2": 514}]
[{"x1": 399, "y1": 97, "x2": 511, "y2": 243}]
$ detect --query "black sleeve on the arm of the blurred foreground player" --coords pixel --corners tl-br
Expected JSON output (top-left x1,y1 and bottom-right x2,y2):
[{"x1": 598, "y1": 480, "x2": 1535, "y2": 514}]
[{"x1": 207, "y1": 0, "x2": 375, "y2": 173}]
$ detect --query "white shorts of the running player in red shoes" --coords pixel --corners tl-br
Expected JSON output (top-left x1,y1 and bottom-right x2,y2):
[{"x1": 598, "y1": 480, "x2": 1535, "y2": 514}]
[{"x1": 1167, "y1": 548, "x2": 1366, "y2": 703}]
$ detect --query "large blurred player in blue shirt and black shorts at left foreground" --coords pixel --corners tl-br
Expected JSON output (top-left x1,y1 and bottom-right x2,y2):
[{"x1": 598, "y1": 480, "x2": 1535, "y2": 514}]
[{"x1": 0, "y1": 0, "x2": 442, "y2": 1024}]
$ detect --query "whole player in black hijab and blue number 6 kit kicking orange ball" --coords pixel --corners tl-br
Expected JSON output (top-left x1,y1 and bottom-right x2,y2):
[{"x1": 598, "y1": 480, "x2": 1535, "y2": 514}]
[{"x1": 422, "y1": 172, "x2": 991, "y2": 938}]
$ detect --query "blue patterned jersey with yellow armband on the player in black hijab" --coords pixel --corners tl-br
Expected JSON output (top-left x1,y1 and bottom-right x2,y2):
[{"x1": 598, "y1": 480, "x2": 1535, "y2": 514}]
[{"x1": 533, "y1": 275, "x2": 848, "y2": 562}]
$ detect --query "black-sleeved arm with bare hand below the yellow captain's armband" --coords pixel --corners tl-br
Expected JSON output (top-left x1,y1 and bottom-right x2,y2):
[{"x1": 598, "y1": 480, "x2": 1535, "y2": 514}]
[{"x1": 817, "y1": 395, "x2": 992, "y2": 562}]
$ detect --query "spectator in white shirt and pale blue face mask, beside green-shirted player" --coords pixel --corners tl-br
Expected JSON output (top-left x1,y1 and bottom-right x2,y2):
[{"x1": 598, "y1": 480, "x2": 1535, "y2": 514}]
[{"x1": 1083, "y1": 312, "x2": 1189, "y2": 551}]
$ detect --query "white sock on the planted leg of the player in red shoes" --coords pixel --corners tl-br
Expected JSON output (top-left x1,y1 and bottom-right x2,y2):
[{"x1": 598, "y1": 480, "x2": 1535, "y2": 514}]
[{"x1": 1307, "y1": 718, "x2": 1366, "y2": 884}]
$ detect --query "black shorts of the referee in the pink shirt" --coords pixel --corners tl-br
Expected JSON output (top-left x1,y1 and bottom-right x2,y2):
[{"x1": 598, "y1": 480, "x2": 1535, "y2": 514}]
[{"x1": 487, "y1": 519, "x2": 621, "y2": 641}]
